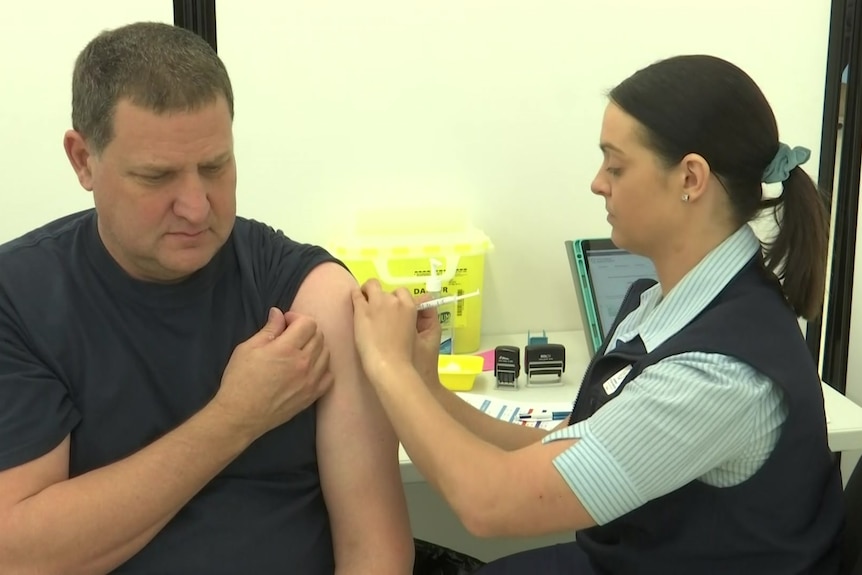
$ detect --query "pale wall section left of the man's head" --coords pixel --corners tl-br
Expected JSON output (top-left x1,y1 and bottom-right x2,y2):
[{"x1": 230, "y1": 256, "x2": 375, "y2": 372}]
[{"x1": 0, "y1": 0, "x2": 174, "y2": 236}]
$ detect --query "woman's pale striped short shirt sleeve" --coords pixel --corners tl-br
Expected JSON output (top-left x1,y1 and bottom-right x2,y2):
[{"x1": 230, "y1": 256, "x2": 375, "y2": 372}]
[{"x1": 543, "y1": 352, "x2": 787, "y2": 525}]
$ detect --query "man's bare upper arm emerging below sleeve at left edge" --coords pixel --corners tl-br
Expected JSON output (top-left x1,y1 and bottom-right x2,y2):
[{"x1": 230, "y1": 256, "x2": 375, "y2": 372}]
[{"x1": 0, "y1": 436, "x2": 70, "y2": 520}]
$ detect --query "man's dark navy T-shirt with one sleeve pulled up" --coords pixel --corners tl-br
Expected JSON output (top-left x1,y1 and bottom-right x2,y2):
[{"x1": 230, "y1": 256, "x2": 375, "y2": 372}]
[{"x1": 0, "y1": 210, "x2": 336, "y2": 575}]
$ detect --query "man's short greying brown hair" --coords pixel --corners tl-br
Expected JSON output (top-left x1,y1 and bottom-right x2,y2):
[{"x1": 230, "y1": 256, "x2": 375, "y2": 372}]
[{"x1": 72, "y1": 22, "x2": 233, "y2": 154}]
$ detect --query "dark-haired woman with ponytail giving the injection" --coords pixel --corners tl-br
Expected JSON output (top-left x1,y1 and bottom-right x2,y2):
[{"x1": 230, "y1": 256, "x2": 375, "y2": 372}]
[{"x1": 354, "y1": 56, "x2": 842, "y2": 575}]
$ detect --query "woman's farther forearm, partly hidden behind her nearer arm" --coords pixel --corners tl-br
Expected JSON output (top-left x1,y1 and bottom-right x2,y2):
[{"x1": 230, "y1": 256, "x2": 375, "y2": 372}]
[{"x1": 426, "y1": 376, "x2": 548, "y2": 451}]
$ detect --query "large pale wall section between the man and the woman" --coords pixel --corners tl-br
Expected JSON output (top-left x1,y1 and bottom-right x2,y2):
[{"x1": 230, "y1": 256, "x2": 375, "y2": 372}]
[{"x1": 213, "y1": 0, "x2": 829, "y2": 333}]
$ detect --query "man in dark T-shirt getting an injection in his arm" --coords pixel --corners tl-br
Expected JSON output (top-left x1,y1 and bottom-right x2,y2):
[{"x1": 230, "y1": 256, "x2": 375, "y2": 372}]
[{"x1": 0, "y1": 23, "x2": 413, "y2": 575}]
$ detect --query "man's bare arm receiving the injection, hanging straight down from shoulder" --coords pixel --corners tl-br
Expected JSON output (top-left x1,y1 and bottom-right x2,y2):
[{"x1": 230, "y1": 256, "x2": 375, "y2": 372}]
[{"x1": 292, "y1": 263, "x2": 413, "y2": 574}]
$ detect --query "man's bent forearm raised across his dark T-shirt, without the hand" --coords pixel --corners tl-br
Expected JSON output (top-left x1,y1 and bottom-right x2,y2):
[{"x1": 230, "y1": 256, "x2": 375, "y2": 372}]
[{"x1": 0, "y1": 406, "x2": 254, "y2": 574}]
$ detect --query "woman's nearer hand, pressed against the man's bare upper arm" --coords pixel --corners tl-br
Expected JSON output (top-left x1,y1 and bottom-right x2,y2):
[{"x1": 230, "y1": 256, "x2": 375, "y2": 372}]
[{"x1": 353, "y1": 279, "x2": 417, "y2": 379}]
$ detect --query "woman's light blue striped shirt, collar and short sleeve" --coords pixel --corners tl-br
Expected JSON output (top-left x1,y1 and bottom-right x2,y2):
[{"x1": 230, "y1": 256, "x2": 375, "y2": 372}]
[{"x1": 544, "y1": 225, "x2": 787, "y2": 525}]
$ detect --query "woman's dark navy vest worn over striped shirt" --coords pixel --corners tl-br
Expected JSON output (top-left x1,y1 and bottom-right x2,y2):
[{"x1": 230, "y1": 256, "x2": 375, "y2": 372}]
[{"x1": 570, "y1": 255, "x2": 843, "y2": 575}]
